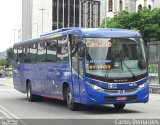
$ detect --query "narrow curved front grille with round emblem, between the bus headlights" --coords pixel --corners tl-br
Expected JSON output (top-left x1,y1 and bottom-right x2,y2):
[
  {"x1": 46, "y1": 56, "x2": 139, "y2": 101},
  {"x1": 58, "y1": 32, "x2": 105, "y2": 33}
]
[{"x1": 104, "y1": 88, "x2": 138, "y2": 94}]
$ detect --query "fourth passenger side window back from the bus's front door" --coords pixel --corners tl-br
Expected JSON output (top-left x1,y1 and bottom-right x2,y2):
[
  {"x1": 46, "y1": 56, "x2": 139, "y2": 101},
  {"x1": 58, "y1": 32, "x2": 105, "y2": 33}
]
[{"x1": 29, "y1": 44, "x2": 37, "y2": 62}]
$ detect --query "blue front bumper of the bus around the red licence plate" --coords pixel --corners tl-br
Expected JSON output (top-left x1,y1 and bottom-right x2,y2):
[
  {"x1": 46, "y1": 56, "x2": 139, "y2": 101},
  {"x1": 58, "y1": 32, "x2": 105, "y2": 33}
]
[{"x1": 81, "y1": 85, "x2": 149, "y2": 105}]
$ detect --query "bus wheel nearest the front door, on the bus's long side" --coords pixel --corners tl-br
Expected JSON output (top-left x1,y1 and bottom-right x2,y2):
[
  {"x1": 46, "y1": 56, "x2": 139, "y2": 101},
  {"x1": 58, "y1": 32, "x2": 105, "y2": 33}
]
[{"x1": 66, "y1": 87, "x2": 77, "y2": 111}]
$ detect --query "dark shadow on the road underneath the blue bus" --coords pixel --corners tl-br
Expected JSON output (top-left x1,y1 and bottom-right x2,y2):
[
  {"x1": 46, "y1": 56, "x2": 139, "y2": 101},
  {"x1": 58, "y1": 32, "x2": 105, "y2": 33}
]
[{"x1": 21, "y1": 98, "x2": 143, "y2": 114}]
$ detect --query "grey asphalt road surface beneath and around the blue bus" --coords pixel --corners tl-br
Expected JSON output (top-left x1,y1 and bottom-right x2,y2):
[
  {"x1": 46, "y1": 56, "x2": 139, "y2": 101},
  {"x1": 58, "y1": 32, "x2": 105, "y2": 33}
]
[{"x1": 0, "y1": 78, "x2": 160, "y2": 124}]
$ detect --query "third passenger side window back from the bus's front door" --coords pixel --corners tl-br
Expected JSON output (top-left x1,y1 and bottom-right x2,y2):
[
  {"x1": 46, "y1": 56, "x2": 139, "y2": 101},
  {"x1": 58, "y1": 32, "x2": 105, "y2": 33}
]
[{"x1": 37, "y1": 42, "x2": 46, "y2": 62}]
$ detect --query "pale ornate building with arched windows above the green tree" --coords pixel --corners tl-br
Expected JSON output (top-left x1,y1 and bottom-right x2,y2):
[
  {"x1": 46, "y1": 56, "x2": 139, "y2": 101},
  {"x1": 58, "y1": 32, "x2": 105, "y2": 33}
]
[{"x1": 99, "y1": 0, "x2": 155, "y2": 21}]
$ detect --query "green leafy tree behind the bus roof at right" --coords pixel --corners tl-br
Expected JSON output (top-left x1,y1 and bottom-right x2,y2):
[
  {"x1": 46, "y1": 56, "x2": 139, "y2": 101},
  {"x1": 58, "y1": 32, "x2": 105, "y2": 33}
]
[{"x1": 101, "y1": 8, "x2": 160, "y2": 42}]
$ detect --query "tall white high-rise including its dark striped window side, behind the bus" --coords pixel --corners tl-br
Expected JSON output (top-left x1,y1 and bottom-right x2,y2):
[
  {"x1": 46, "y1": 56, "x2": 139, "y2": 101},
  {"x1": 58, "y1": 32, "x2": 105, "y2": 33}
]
[{"x1": 22, "y1": 0, "x2": 100, "y2": 40}]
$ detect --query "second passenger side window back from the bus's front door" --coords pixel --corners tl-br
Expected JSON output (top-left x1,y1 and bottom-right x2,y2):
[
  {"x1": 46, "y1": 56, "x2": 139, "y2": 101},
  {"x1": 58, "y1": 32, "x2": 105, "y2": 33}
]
[{"x1": 47, "y1": 40, "x2": 57, "y2": 62}]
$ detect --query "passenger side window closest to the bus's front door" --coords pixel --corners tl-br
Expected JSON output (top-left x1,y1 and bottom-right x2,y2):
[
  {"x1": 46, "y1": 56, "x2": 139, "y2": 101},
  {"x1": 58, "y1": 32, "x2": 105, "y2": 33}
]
[{"x1": 57, "y1": 37, "x2": 69, "y2": 61}]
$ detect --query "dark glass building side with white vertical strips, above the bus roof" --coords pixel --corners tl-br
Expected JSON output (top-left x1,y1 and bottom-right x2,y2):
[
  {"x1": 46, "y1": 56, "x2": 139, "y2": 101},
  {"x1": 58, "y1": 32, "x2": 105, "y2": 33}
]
[{"x1": 52, "y1": 0, "x2": 100, "y2": 30}]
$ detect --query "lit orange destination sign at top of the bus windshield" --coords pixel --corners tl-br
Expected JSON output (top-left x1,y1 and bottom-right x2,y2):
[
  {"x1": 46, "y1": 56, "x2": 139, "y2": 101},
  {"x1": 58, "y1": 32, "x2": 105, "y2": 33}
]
[{"x1": 86, "y1": 42, "x2": 112, "y2": 47}]
